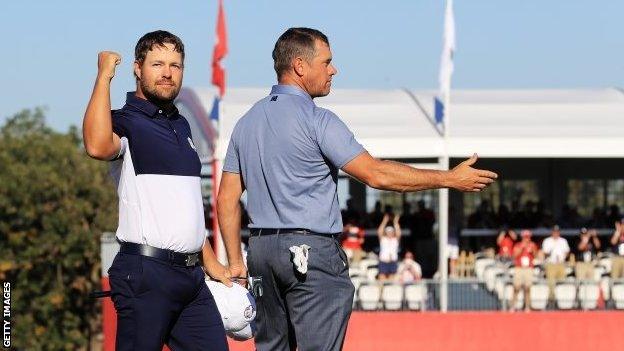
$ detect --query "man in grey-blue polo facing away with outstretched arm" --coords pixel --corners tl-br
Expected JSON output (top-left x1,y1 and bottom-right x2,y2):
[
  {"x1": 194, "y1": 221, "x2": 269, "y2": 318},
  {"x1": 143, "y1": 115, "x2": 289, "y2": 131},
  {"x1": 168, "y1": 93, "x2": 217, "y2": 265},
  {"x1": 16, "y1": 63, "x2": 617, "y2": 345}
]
[{"x1": 217, "y1": 28, "x2": 497, "y2": 351}]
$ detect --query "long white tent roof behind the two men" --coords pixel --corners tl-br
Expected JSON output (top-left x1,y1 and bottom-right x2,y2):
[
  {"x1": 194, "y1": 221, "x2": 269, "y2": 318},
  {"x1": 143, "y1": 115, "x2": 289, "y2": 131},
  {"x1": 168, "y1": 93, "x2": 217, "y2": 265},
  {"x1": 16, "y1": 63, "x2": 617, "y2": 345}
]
[{"x1": 184, "y1": 88, "x2": 624, "y2": 158}]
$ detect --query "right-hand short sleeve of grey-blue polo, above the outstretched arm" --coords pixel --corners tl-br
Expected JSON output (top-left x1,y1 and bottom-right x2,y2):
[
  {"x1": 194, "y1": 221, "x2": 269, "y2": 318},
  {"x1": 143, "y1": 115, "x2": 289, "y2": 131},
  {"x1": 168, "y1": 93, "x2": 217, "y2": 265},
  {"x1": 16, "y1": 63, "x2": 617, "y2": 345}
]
[{"x1": 316, "y1": 110, "x2": 366, "y2": 168}]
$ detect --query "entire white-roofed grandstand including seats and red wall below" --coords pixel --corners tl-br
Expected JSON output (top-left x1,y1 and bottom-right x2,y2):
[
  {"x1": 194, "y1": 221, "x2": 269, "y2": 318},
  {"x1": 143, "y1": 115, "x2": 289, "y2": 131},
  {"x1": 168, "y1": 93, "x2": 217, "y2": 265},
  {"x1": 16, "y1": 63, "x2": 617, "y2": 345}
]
[{"x1": 92, "y1": 88, "x2": 624, "y2": 350}]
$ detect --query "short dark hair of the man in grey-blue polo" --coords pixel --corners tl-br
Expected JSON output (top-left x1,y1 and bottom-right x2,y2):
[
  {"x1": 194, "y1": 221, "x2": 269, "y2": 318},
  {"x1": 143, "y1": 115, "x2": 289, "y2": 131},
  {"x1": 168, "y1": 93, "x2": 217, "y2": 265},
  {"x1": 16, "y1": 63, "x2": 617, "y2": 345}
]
[{"x1": 273, "y1": 27, "x2": 329, "y2": 78}]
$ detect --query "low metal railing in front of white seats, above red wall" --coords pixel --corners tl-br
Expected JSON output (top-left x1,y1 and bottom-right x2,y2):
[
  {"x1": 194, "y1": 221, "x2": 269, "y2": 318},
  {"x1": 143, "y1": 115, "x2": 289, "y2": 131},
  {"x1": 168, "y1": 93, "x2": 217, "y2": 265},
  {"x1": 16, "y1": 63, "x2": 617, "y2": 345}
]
[{"x1": 351, "y1": 276, "x2": 624, "y2": 311}]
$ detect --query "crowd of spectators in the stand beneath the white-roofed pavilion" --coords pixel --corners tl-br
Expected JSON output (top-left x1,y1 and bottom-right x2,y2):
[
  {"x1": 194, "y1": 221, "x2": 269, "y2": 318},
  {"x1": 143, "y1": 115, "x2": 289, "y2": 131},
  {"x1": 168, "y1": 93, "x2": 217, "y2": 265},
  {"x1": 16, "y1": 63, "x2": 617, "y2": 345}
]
[{"x1": 207, "y1": 200, "x2": 624, "y2": 288}]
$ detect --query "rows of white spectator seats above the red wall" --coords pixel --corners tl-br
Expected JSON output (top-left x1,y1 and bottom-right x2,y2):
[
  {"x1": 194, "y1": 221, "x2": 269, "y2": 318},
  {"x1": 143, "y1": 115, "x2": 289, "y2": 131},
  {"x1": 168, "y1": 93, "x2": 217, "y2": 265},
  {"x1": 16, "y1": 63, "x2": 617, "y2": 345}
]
[{"x1": 349, "y1": 253, "x2": 624, "y2": 312}]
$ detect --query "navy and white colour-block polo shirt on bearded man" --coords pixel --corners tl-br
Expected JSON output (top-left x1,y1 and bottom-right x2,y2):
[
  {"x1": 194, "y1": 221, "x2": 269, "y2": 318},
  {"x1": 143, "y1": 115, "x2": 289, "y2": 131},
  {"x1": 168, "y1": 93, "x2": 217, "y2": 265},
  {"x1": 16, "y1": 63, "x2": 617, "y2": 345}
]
[{"x1": 111, "y1": 92, "x2": 205, "y2": 253}]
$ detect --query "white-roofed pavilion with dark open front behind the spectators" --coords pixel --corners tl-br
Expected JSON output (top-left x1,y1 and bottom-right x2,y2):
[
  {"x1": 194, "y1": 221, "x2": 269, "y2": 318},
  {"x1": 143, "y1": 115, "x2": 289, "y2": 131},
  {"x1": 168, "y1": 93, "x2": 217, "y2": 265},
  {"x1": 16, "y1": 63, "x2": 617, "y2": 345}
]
[{"x1": 177, "y1": 88, "x2": 624, "y2": 278}]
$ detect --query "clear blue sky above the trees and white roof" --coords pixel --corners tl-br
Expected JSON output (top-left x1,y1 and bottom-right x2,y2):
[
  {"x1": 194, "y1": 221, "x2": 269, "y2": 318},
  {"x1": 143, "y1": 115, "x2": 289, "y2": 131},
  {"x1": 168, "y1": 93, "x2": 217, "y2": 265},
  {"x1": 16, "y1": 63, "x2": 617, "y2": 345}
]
[{"x1": 0, "y1": 0, "x2": 624, "y2": 130}]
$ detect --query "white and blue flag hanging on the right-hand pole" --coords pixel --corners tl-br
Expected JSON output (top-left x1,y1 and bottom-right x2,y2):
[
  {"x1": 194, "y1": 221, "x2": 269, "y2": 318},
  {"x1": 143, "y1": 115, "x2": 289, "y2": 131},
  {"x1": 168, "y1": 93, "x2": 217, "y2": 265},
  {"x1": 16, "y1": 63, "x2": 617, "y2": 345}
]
[{"x1": 434, "y1": 0, "x2": 455, "y2": 124}]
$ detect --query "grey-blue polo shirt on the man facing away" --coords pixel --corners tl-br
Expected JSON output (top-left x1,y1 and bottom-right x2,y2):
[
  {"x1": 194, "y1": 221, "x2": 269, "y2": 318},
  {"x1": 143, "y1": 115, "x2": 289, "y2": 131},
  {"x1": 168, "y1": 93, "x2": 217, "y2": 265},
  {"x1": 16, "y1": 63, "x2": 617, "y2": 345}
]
[{"x1": 223, "y1": 85, "x2": 365, "y2": 233}]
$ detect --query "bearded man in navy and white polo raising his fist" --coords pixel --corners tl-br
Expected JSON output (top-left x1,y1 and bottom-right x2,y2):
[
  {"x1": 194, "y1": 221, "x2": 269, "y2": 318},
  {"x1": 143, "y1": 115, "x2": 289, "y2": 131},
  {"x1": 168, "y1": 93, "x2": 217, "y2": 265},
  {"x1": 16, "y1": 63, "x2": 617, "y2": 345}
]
[{"x1": 83, "y1": 31, "x2": 232, "y2": 351}]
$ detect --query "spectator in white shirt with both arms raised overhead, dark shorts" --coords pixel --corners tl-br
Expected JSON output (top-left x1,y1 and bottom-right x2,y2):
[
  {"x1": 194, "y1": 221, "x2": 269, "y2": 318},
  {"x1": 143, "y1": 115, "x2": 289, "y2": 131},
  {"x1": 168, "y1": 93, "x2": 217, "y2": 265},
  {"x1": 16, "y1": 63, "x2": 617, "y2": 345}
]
[{"x1": 377, "y1": 213, "x2": 401, "y2": 281}]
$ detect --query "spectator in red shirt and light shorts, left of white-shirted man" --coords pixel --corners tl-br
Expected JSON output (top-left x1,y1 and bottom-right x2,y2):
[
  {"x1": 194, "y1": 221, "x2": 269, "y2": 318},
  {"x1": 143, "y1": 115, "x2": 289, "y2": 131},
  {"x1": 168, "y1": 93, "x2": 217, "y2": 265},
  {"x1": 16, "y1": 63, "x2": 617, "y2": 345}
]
[{"x1": 509, "y1": 229, "x2": 538, "y2": 311}]
